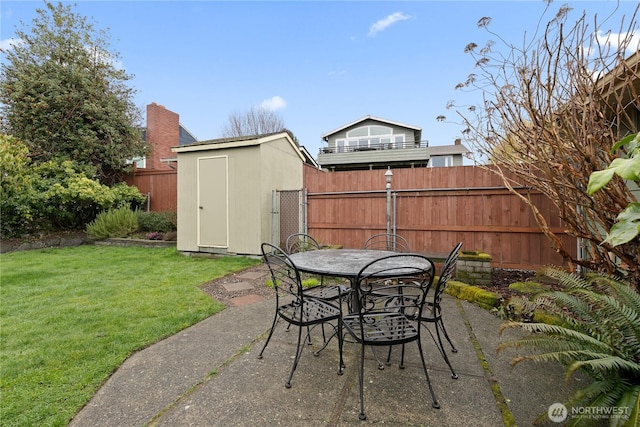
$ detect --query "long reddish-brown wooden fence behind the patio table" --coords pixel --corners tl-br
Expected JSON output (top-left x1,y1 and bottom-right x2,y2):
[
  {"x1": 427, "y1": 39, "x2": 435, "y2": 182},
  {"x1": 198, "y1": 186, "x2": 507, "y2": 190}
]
[{"x1": 304, "y1": 166, "x2": 577, "y2": 270}]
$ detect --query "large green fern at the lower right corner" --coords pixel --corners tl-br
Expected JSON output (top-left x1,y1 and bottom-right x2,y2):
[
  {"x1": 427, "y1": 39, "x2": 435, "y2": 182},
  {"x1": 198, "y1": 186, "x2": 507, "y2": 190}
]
[{"x1": 498, "y1": 267, "x2": 640, "y2": 427}]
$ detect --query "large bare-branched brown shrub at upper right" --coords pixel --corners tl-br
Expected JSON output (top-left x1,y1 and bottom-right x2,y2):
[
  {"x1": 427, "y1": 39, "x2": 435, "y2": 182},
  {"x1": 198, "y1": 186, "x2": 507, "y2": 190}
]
[{"x1": 447, "y1": 6, "x2": 640, "y2": 281}]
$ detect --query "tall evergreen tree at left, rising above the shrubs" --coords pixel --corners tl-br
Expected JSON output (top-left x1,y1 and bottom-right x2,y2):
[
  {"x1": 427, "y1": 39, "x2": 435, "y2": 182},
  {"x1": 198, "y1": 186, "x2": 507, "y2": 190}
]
[{"x1": 0, "y1": 3, "x2": 144, "y2": 184}]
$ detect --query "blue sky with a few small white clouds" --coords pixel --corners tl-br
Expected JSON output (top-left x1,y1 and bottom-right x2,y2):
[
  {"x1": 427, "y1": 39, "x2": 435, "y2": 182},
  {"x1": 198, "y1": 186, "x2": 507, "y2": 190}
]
[{"x1": 0, "y1": 0, "x2": 637, "y2": 161}]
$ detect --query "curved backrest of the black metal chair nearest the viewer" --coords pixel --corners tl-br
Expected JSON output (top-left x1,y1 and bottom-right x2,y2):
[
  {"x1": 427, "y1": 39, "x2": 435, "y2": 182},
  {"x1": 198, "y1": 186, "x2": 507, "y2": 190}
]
[{"x1": 354, "y1": 254, "x2": 435, "y2": 318}]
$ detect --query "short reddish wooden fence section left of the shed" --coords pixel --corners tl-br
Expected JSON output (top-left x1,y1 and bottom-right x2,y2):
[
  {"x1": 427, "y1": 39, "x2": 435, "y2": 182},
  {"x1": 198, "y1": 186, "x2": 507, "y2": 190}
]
[{"x1": 125, "y1": 169, "x2": 178, "y2": 212}]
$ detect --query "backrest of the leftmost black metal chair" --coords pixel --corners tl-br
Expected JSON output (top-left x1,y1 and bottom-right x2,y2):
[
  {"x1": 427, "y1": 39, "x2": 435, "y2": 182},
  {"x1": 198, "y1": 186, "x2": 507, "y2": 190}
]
[{"x1": 261, "y1": 243, "x2": 302, "y2": 302}]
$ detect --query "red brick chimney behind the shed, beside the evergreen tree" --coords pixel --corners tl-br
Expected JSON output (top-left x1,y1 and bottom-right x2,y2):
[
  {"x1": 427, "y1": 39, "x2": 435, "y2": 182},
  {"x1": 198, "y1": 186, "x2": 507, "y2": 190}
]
[{"x1": 146, "y1": 102, "x2": 180, "y2": 170}]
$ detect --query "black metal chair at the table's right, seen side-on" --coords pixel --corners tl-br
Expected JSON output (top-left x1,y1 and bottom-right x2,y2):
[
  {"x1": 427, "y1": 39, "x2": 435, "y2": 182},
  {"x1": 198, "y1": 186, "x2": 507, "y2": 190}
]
[{"x1": 420, "y1": 242, "x2": 462, "y2": 379}]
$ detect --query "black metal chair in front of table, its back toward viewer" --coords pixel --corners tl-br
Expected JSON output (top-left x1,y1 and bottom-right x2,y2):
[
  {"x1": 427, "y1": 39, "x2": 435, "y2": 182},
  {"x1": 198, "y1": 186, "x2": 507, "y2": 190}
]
[{"x1": 342, "y1": 254, "x2": 440, "y2": 420}]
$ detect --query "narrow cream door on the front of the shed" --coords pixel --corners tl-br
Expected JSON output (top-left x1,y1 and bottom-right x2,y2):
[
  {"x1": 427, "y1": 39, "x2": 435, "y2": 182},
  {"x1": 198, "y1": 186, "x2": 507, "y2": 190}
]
[{"x1": 198, "y1": 156, "x2": 229, "y2": 248}]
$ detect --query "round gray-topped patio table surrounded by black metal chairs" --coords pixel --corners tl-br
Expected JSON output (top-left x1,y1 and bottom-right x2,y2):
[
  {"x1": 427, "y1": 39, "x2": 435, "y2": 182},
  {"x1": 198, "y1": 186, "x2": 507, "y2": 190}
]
[{"x1": 289, "y1": 249, "x2": 431, "y2": 311}]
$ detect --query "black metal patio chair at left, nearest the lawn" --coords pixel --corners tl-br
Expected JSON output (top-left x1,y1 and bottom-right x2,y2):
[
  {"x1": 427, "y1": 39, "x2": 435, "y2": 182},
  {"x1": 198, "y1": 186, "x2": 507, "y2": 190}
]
[{"x1": 258, "y1": 243, "x2": 344, "y2": 388}]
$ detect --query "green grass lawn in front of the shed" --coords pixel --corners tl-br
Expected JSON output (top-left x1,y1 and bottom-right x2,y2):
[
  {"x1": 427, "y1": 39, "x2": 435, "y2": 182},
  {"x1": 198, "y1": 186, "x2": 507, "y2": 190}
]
[{"x1": 0, "y1": 246, "x2": 259, "y2": 426}]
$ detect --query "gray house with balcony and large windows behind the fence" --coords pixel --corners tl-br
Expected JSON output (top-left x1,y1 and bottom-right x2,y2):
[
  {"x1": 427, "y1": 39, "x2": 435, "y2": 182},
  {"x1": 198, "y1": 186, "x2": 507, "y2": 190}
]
[{"x1": 317, "y1": 116, "x2": 469, "y2": 171}]
